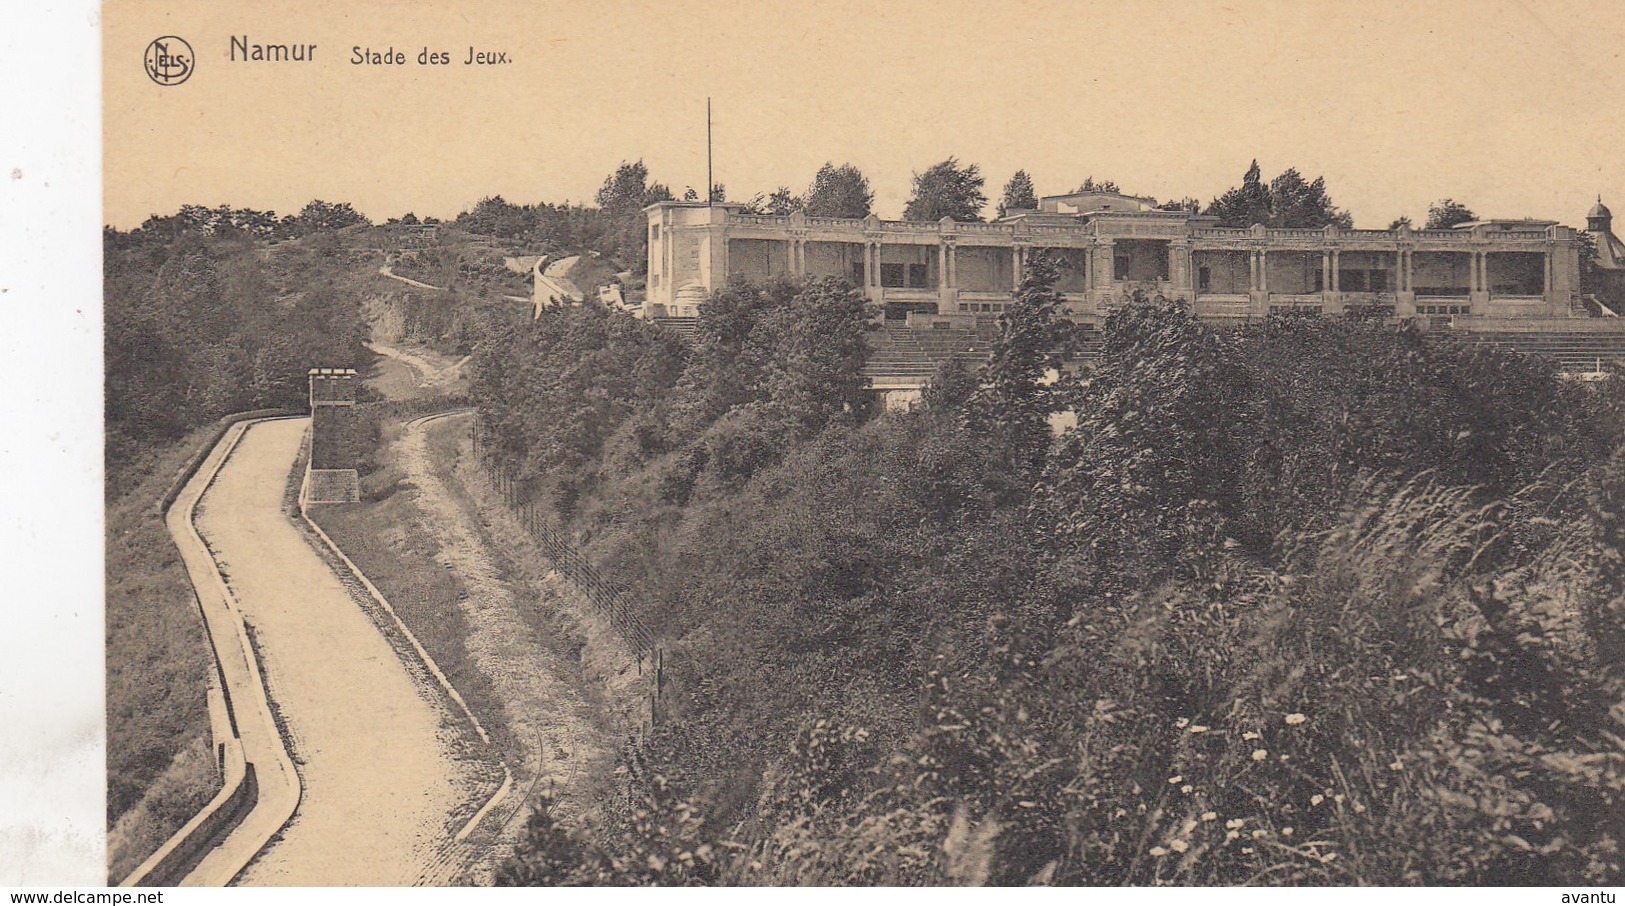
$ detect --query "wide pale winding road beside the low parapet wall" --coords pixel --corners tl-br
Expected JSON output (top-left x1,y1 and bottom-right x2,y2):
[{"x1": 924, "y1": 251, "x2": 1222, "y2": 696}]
[{"x1": 197, "y1": 419, "x2": 483, "y2": 885}]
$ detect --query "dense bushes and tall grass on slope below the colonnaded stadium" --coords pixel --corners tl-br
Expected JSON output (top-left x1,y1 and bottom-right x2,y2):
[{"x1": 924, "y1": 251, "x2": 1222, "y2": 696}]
[{"x1": 475, "y1": 261, "x2": 1625, "y2": 885}]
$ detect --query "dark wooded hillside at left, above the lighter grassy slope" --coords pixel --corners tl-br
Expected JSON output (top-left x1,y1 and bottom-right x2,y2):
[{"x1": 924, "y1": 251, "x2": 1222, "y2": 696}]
[{"x1": 102, "y1": 212, "x2": 372, "y2": 492}]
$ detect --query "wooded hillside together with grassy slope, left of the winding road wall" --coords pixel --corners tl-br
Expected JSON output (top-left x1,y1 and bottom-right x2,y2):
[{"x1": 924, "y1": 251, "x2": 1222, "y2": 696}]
[{"x1": 104, "y1": 201, "x2": 377, "y2": 880}]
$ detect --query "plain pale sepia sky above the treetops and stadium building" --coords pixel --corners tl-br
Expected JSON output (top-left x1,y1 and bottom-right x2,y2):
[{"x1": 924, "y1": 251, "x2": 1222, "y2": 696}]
[{"x1": 102, "y1": 0, "x2": 1625, "y2": 227}]
